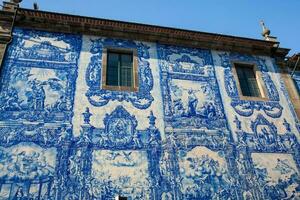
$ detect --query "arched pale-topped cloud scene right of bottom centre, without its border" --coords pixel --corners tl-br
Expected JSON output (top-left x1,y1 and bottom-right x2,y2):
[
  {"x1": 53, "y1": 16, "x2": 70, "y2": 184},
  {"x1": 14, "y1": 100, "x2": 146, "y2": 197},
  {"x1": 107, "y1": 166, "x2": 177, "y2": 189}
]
[{"x1": 179, "y1": 147, "x2": 230, "y2": 199}]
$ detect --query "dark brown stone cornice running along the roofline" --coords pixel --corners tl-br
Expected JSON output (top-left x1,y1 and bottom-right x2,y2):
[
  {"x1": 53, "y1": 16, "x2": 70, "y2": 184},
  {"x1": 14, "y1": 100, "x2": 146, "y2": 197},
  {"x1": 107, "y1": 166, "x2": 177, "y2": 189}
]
[{"x1": 0, "y1": 8, "x2": 289, "y2": 58}]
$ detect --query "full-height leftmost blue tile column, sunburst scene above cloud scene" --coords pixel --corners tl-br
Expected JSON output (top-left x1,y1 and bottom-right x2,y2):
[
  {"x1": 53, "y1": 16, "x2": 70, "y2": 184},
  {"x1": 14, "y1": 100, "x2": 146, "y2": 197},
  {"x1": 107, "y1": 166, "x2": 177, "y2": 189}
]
[{"x1": 0, "y1": 28, "x2": 82, "y2": 199}]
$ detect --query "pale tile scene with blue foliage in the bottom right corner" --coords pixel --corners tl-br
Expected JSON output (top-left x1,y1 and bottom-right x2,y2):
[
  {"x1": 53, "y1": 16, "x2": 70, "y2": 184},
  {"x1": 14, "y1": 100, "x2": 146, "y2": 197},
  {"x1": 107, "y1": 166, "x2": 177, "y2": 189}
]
[{"x1": 251, "y1": 153, "x2": 300, "y2": 199}]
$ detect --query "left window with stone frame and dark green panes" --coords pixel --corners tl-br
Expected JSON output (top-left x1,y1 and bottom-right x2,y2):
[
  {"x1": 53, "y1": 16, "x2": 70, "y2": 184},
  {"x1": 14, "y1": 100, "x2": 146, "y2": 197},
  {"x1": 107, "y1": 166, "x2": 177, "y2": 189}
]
[{"x1": 102, "y1": 48, "x2": 137, "y2": 91}]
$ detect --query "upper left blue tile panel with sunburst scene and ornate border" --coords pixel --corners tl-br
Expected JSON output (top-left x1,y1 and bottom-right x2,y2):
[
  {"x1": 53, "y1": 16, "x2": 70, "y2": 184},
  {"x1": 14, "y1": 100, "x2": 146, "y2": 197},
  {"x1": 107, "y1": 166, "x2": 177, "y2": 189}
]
[{"x1": 0, "y1": 29, "x2": 81, "y2": 122}]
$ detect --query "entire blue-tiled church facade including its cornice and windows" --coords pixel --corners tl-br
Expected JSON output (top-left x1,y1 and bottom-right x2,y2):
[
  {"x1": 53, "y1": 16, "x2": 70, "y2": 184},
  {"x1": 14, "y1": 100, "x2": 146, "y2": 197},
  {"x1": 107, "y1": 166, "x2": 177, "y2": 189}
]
[{"x1": 0, "y1": 2, "x2": 300, "y2": 200}]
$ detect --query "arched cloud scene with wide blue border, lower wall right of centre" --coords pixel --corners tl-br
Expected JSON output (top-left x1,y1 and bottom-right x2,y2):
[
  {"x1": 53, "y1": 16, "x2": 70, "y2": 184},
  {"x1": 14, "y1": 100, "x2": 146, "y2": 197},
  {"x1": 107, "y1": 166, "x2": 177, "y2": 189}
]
[{"x1": 160, "y1": 130, "x2": 241, "y2": 199}]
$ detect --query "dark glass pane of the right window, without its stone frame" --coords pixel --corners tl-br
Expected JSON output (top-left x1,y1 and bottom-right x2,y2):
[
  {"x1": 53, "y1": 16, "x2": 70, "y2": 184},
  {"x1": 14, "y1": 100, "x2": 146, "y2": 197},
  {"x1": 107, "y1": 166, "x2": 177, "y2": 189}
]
[{"x1": 236, "y1": 65, "x2": 261, "y2": 97}]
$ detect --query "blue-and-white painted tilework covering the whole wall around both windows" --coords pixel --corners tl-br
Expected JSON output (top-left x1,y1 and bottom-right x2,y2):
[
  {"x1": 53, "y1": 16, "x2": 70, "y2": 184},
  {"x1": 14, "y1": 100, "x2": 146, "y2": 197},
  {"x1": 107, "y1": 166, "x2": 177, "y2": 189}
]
[{"x1": 0, "y1": 29, "x2": 300, "y2": 200}]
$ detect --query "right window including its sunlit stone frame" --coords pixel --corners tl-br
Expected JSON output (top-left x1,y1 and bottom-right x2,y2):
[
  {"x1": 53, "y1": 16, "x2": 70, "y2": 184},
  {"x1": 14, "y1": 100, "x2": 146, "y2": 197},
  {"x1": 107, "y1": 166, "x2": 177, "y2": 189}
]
[{"x1": 234, "y1": 63, "x2": 265, "y2": 99}]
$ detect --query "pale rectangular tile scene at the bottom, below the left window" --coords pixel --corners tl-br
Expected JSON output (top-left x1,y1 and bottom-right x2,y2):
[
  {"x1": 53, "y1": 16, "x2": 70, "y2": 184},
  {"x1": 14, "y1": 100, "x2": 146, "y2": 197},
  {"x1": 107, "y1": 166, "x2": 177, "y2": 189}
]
[{"x1": 92, "y1": 150, "x2": 150, "y2": 199}]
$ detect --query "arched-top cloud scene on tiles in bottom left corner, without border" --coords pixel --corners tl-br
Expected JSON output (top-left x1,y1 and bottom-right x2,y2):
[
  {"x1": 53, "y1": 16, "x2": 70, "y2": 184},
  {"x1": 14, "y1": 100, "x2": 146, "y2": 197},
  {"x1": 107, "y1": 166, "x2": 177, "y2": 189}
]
[{"x1": 0, "y1": 143, "x2": 57, "y2": 199}]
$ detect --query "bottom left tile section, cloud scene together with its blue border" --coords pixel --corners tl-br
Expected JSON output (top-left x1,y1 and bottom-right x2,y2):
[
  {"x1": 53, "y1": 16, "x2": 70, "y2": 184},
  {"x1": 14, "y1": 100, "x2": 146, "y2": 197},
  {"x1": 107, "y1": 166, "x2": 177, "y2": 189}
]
[{"x1": 0, "y1": 123, "x2": 72, "y2": 199}]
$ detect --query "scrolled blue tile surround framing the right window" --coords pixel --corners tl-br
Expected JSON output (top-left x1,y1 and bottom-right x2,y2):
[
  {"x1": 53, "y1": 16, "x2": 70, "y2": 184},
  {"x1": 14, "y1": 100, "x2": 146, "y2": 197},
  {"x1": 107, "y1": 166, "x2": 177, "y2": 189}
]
[{"x1": 219, "y1": 53, "x2": 283, "y2": 118}]
